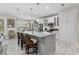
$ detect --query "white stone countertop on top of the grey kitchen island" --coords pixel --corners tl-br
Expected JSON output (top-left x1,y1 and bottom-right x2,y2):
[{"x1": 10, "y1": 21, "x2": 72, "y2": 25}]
[{"x1": 18, "y1": 31, "x2": 55, "y2": 37}]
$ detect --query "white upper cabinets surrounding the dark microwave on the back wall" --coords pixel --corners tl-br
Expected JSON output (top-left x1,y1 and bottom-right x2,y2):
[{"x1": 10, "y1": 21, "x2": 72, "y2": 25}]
[{"x1": 44, "y1": 15, "x2": 59, "y2": 27}]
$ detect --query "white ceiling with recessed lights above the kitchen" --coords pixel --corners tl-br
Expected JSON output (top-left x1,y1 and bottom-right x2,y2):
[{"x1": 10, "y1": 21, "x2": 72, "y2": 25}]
[{"x1": 0, "y1": 3, "x2": 78, "y2": 19}]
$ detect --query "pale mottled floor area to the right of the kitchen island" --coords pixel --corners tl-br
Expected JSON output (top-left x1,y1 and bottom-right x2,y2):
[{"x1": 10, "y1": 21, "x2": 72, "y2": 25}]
[{"x1": 55, "y1": 41, "x2": 79, "y2": 55}]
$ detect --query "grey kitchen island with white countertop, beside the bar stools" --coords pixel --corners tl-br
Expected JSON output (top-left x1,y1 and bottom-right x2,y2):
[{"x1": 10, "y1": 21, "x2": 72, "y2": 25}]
[{"x1": 20, "y1": 31, "x2": 56, "y2": 55}]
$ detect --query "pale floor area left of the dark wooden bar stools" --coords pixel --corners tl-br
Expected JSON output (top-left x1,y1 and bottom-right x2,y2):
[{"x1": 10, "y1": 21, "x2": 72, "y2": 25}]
[{"x1": 2, "y1": 39, "x2": 24, "y2": 55}]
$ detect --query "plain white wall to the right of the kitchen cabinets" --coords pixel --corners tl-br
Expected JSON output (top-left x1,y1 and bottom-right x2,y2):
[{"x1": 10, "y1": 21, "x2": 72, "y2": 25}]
[{"x1": 59, "y1": 8, "x2": 75, "y2": 43}]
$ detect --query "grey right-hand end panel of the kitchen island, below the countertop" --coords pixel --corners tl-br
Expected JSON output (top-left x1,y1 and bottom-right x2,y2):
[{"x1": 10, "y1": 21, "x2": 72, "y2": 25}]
[{"x1": 44, "y1": 34, "x2": 56, "y2": 55}]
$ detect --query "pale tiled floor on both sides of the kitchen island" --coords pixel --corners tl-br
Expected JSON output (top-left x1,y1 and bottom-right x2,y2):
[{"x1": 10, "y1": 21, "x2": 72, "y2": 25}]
[{"x1": 2, "y1": 39, "x2": 79, "y2": 55}]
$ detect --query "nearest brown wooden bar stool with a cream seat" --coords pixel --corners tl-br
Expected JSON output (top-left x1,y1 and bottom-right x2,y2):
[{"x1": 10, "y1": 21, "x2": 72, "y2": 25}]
[{"x1": 25, "y1": 36, "x2": 37, "y2": 55}]
